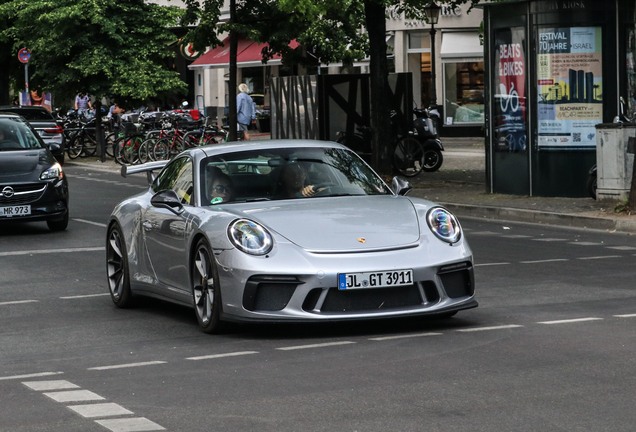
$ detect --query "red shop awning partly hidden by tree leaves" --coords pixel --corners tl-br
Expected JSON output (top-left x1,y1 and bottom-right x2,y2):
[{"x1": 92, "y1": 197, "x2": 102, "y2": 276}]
[{"x1": 188, "y1": 37, "x2": 299, "y2": 69}]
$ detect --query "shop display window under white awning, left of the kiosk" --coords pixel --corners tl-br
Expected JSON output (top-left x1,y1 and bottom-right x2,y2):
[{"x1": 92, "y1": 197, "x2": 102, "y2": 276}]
[{"x1": 444, "y1": 62, "x2": 484, "y2": 126}]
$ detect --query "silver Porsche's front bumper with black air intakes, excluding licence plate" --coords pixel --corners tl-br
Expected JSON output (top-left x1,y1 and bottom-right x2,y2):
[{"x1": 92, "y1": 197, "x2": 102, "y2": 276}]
[{"x1": 216, "y1": 244, "x2": 477, "y2": 322}]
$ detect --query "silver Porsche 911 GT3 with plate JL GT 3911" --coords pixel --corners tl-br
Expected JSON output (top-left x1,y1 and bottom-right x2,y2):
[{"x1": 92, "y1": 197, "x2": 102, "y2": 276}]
[{"x1": 106, "y1": 140, "x2": 477, "y2": 333}]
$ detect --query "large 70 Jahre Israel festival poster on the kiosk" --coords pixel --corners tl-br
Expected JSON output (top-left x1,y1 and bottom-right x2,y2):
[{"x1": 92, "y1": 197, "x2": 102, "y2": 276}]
[{"x1": 537, "y1": 27, "x2": 603, "y2": 149}]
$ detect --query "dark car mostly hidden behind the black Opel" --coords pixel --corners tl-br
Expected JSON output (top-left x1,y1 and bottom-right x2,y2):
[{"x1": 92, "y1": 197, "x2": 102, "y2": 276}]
[{"x1": 0, "y1": 106, "x2": 66, "y2": 165}]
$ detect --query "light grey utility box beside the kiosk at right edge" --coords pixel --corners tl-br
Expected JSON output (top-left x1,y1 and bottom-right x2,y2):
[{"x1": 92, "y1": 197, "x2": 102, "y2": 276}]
[{"x1": 596, "y1": 123, "x2": 636, "y2": 201}]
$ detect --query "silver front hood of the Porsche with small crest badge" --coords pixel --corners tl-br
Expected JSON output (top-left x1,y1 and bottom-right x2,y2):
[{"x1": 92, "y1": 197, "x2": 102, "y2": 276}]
[{"x1": 233, "y1": 195, "x2": 420, "y2": 252}]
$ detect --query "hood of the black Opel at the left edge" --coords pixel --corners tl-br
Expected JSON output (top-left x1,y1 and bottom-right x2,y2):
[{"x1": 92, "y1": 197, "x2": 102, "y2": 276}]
[{"x1": 0, "y1": 149, "x2": 55, "y2": 183}]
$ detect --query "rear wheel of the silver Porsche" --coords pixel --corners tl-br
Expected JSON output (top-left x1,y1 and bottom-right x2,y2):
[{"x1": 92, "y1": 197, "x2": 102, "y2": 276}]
[{"x1": 106, "y1": 224, "x2": 133, "y2": 308}]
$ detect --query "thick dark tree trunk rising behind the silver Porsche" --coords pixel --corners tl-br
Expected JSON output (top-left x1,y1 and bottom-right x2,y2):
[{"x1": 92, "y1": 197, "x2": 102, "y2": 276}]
[{"x1": 364, "y1": 0, "x2": 393, "y2": 174}]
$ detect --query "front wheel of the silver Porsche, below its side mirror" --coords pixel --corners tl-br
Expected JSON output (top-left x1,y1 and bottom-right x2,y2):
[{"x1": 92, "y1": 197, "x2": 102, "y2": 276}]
[{"x1": 190, "y1": 239, "x2": 223, "y2": 333}]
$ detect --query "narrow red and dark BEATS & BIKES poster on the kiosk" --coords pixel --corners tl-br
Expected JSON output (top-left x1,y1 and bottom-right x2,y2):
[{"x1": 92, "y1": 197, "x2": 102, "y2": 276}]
[{"x1": 494, "y1": 27, "x2": 526, "y2": 152}]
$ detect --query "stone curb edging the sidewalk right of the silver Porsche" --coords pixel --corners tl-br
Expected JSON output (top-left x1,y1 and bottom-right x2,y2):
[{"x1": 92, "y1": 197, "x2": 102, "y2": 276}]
[{"x1": 439, "y1": 202, "x2": 636, "y2": 233}]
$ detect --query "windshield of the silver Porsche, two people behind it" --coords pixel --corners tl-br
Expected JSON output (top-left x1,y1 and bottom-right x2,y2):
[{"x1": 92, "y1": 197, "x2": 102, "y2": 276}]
[{"x1": 200, "y1": 147, "x2": 391, "y2": 205}]
